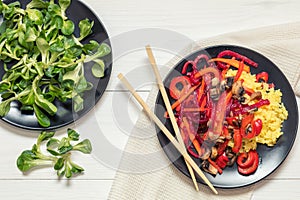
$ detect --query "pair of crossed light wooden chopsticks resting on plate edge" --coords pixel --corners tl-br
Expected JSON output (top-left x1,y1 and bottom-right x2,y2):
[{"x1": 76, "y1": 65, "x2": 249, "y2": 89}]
[{"x1": 118, "y1": 45, "x2": 218, "y2": 194}]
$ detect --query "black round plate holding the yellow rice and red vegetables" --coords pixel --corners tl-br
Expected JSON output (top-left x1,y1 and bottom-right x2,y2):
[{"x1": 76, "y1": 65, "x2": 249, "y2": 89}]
[{"x1": 155, "y1": 45, "x2": 298, "y2": 188}]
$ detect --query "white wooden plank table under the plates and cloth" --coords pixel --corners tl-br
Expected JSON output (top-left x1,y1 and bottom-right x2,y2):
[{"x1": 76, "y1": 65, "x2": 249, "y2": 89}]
[{"x1": 0, "y1": 0, "x2": 300, "y2": 200}]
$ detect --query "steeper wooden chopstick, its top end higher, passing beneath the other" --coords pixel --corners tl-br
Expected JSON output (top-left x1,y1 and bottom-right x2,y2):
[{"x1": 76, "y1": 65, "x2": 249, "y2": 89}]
[{"x1": 146, "y1": 45, "x2": 199, "y2": 191}]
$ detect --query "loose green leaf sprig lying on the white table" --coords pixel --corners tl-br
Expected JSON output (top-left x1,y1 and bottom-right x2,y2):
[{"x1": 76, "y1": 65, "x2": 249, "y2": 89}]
[{"x1": 17, "y1": 129, "x2": 92, "y2": 178}]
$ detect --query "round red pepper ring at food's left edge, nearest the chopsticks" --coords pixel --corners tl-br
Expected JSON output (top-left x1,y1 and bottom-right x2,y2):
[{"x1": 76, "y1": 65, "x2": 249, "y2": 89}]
[{"x1": 169, "y1": 76, "x2": 191, "y2": 99}]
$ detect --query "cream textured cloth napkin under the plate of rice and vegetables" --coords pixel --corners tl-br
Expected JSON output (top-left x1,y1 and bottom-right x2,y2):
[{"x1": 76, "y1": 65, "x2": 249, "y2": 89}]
[{"x1": 109, "y1": 22, "x2": 300, "y2": 200}]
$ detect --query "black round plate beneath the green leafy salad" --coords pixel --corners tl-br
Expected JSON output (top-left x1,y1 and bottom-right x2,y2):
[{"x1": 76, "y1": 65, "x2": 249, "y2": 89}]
[{"x1": 0, "y1": 0, "x2": 112, "y2": 130}]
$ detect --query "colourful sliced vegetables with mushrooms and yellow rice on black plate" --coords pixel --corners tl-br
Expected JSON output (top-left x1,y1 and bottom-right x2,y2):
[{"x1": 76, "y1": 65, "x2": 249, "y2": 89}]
[{"x1": 165, "y1": 50, "x2": 288, "y2": 175}]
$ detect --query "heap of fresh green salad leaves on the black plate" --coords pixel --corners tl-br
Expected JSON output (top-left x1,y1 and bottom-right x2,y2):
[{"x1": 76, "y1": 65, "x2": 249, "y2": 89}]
[{"x1": 0, "y1": 0, "x2": 111, "y2": 127}]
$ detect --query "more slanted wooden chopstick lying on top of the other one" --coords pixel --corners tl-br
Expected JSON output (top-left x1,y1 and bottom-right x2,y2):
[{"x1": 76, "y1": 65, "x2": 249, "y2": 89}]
[{"x1": 118, "y1": 73, "x2": 218, "y2": 194}]
